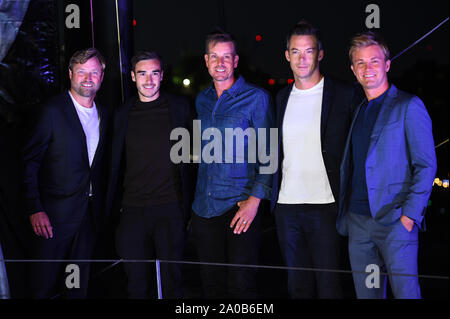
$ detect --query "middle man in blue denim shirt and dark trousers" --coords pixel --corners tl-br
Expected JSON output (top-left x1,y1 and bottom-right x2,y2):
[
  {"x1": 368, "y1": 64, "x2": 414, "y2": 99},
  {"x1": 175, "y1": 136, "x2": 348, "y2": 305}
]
[{"x1": 192, "y1": 33, "x2": 277, "y2": 298}]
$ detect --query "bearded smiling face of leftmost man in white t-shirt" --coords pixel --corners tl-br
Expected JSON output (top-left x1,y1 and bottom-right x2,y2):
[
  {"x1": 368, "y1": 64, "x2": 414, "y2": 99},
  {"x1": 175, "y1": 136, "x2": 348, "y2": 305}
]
[{"x1": 69, "y1": 57, "x2": 103, "y2": 98}]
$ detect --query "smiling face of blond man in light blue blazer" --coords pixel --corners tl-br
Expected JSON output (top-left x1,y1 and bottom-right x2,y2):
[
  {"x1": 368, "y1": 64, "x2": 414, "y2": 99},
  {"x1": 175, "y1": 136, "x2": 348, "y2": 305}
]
[{"x1": 351, "y1": 45, "x2": 391, "y2": 99}]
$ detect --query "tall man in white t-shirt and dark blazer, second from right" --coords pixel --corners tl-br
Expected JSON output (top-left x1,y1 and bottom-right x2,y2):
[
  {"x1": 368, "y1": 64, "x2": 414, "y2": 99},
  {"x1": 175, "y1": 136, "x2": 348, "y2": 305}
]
[{"x1": 271, "y1": 21, "x2": 354, "y2": 298}]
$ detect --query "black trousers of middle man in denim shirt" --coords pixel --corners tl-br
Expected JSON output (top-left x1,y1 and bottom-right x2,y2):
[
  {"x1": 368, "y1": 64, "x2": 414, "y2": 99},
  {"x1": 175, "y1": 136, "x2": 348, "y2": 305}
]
[{"x1": 192, "y1": 206, "x2": 261, "y2": 299}]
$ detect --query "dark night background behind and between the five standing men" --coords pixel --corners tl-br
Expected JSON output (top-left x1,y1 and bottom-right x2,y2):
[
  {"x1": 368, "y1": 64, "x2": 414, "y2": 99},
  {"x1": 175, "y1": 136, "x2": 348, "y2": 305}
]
[{"x1": 0, "y1": 0, "x2": 449, "y2": 298}]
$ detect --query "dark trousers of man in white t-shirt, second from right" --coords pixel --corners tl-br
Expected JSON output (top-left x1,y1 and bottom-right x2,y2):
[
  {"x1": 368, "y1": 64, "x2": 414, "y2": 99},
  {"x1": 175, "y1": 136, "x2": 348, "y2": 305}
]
[{"x1": 274, "y1": 203, "x2": 343, "y2": 299}]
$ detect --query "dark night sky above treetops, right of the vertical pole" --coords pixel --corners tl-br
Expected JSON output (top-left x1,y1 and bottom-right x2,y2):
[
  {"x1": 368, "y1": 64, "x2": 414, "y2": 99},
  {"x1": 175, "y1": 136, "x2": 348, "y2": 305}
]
[{"x1": 133, "y1": 0, "x2": 449, "y2": 81}]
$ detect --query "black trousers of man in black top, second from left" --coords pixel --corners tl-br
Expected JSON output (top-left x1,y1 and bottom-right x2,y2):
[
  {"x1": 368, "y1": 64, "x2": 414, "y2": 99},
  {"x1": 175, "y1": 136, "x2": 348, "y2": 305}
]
[{"x1": 116, "y1": 203, "x2": 186, "y2": 299}]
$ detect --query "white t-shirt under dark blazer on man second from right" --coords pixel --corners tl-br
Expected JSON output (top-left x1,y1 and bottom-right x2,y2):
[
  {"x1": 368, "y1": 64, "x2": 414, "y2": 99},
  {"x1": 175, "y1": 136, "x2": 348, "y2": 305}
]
[{"x1": 278, "y1": 78, "x2": 335, "y2": 204}]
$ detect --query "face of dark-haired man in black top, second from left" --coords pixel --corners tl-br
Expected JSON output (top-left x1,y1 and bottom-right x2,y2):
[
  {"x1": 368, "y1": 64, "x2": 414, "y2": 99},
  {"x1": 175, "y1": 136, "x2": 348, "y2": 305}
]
[{"x1": 131, "y1": 59, "x2": 163, "y2": 102}]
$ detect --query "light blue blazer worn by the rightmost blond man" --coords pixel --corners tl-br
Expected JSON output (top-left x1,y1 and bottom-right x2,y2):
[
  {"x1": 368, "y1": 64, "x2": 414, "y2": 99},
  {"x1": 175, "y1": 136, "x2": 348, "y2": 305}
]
[{"x1": 336, "y1": 85, "x2": 436, "y2": 236}]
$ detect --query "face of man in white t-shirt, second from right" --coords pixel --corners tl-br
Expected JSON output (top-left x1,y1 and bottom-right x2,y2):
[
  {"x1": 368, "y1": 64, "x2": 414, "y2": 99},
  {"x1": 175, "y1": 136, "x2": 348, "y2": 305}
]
[{"x1": 285, "y1": 35, "x2": 323, "y2": 84}]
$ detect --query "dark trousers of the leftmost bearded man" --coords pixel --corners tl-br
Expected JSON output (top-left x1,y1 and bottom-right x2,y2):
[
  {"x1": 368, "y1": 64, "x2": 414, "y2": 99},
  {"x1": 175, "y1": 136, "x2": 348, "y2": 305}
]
[{"x1": 30, "y1": 200, "x2": 97, "y2": 299}]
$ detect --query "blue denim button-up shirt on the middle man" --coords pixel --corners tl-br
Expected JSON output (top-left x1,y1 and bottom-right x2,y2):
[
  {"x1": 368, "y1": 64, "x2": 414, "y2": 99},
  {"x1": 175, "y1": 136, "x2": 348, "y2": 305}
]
[{"x1": 192, "y1": 77, "x2": 275, "y2": 218}]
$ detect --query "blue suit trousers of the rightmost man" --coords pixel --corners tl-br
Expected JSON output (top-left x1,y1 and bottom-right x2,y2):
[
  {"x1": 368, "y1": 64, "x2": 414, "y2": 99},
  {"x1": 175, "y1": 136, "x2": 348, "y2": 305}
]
[{"x1": 348, "y1": 213, "x2": 421, "y2": 299}]
